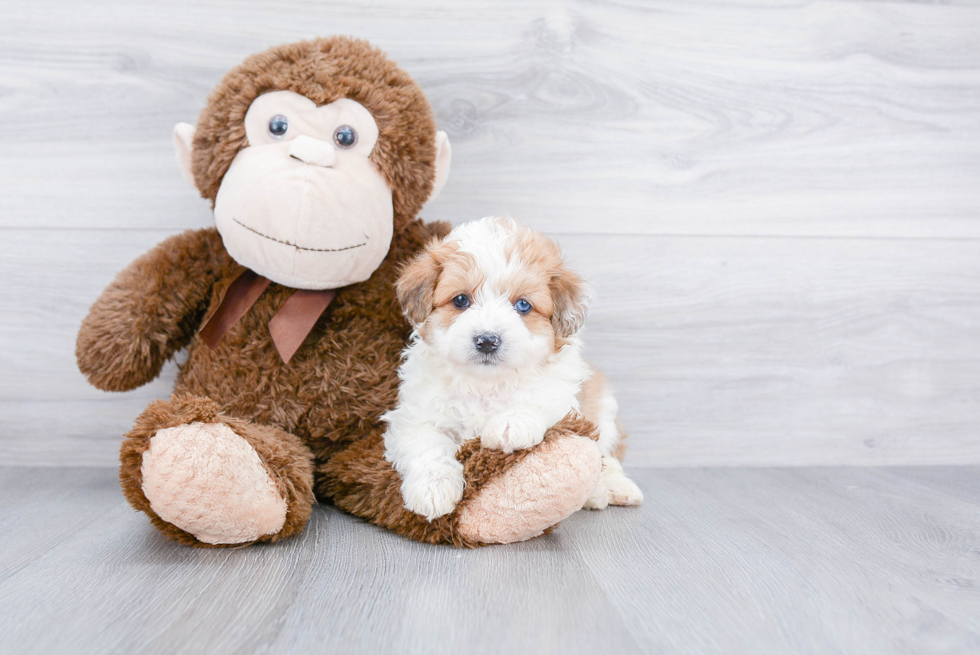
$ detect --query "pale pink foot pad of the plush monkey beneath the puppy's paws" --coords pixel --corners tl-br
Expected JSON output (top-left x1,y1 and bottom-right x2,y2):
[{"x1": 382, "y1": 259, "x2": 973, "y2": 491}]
[{"x1": 458, "y1": 436, "x2": 602, "y2": 544}]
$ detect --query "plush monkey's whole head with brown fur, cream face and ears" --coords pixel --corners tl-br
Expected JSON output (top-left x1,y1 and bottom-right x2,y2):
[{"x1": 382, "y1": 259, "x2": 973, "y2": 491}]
[{"x1": 174, "y1": 36, "x2": 452, "y2": 289}]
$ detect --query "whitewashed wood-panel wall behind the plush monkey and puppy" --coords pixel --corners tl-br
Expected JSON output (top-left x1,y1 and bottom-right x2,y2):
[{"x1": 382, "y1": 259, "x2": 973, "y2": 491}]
[{"x1": 0, "y1": 0, "x2": 980, "y2": 466}]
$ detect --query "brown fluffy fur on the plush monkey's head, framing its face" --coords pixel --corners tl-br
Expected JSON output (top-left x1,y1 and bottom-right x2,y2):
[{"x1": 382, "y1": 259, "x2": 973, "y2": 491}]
[{"x1": 192, "y1": 37, "x2": 436, "y2": 231}]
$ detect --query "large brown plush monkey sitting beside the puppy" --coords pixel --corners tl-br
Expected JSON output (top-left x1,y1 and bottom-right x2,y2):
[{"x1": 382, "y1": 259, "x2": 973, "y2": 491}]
[{"x1": 76, "y1": 38, "x2": 600, "y2": 546}]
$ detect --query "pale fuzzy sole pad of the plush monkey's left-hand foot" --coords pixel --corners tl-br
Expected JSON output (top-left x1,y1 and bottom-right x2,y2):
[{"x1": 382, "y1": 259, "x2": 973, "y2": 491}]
[{"x1": 141, "y1": 423, "x2": 286, "y2": 545}]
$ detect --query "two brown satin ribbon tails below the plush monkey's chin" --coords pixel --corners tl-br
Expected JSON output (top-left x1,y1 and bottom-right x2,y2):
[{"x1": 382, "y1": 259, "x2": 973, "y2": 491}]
[{"x1": 199, "y1": 269, "x2": 337, "y2": 364}]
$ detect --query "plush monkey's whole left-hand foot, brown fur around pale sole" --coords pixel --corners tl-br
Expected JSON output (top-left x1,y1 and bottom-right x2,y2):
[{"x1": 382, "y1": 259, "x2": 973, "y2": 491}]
[{"x1": 119, "y1": 396, "x2": 313, "y2": 546}]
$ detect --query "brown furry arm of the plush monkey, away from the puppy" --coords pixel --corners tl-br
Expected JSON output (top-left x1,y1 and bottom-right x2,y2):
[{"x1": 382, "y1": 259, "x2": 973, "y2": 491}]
[{"x1": 75, "y1": 228, "x2": 227, "y2": 391}]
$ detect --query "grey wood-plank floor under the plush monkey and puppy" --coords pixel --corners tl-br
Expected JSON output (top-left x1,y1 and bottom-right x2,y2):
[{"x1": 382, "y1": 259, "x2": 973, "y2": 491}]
[{"x1": 0, "y1": 467, "x2": 980, "y2": 655}]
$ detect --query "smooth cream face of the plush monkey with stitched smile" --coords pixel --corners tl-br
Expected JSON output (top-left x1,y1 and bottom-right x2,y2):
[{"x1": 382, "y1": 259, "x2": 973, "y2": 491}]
[{"x1": 214, "y1": 91, "x2": 393, "y2": 289}]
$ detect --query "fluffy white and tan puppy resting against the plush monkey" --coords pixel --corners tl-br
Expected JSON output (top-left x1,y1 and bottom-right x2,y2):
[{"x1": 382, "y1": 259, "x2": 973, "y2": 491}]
[{"x1": 382, "y1": 217, "x2": 643, "y2": 521}]
